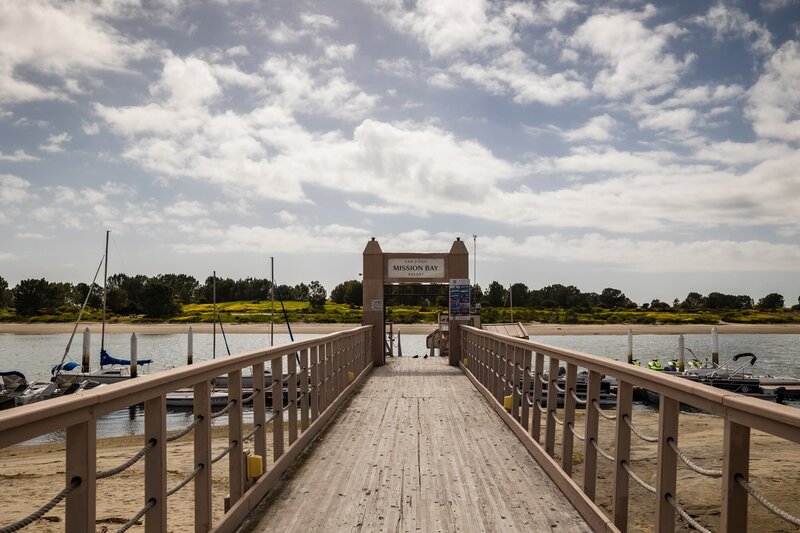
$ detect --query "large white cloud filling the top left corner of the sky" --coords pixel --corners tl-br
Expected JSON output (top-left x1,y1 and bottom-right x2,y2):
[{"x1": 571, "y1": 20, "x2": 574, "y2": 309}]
[{"x1": 0, "y1": 0, "x2": 152, "y2": 103}]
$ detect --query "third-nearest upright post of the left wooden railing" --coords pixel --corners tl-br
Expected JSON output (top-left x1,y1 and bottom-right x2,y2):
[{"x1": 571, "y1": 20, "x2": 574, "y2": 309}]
[{"x1": 193, "y1": 381, "x2": 213, "y2": 533}]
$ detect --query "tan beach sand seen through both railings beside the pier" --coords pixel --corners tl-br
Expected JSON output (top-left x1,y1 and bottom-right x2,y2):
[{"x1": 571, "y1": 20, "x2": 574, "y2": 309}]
[{"x1": 0, "y1": 411, "x2": 800, "y2": 532}]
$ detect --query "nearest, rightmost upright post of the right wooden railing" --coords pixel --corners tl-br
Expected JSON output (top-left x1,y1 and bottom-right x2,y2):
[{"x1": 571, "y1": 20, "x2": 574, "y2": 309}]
[{"x1": 721, "y1": 418, "x2": 750, "y2": 532}]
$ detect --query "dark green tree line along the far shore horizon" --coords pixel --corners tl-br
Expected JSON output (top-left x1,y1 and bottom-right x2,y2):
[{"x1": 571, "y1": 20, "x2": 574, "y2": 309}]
[{"x1": 0, "y1": 274, "x2": 800, "y2": 317}]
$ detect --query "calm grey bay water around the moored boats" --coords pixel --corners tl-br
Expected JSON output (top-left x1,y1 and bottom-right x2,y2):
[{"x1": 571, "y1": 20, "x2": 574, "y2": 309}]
[{"x1": 0, "y1": 333, "x2": 800, "y2": 441}]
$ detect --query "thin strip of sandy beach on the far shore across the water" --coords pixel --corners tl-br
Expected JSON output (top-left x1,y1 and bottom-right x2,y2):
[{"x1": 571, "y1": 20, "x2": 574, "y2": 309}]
[{"x1": 0, "y1": 322, "x2": 800, "y2": 337}]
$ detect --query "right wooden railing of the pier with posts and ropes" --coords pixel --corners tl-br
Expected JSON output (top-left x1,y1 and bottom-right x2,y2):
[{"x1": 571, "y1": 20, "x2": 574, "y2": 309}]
[{"x1": 460, "y1": 327, "x2": 800, "y2": 532}]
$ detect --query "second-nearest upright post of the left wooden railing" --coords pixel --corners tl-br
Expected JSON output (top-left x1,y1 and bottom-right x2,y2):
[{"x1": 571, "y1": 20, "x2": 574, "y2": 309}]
[{"x1": 144, "y1": 396, "x2": 167, "y2": 533}]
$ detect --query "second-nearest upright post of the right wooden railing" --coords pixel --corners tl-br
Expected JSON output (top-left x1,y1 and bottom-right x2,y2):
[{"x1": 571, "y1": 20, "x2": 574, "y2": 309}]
[{"x1": 656, "y1": 394, "x2": 680, "y2": 533}]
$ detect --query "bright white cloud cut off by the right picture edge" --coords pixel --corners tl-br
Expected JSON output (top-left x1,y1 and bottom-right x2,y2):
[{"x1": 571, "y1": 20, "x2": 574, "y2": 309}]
[{"x1": 745, "y1": 41, "x2": 800, "y2": 141}]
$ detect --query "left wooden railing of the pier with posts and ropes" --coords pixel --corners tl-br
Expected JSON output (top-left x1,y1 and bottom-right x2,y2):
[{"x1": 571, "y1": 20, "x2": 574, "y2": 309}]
[{"x1": 0, "y1": 326, "x2": 372, "y2": 532}]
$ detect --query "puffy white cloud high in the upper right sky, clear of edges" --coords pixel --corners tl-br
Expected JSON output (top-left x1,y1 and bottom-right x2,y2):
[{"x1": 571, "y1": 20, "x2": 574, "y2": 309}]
[{"x1": 569, "y1": 7, "x2": 694, "y2": 99}]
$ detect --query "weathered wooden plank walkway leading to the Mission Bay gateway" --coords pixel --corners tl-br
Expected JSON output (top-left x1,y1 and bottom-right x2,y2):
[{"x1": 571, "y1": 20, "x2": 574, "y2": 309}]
[{"x1": 243, "y1": 358, "x2": 591, "y2": 532}]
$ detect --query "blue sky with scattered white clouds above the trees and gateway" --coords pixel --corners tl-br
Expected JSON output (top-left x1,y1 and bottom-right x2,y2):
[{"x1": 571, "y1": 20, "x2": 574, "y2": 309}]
[{"x1": 0, "y1": 0, "x2": 800, "y2": 305}]
